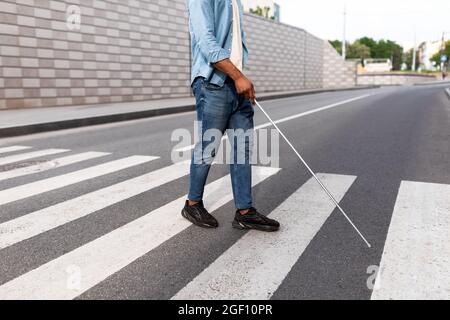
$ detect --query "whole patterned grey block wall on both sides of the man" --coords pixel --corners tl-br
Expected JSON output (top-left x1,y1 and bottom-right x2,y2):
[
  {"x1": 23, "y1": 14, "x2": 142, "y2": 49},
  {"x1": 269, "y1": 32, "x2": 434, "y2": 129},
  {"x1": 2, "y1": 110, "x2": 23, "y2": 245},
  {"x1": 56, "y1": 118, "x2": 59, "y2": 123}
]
[{"x1": 0, "y1": 0, "x2": 349, "y2": 109}]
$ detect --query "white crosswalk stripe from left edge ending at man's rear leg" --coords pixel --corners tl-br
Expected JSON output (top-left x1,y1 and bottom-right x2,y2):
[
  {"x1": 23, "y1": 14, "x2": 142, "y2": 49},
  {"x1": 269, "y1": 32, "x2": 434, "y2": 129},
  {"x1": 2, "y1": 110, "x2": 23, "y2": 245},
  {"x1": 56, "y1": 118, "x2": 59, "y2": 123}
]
[{"x1": 0, "y1": 162, "x2": 190, "y2": 249}]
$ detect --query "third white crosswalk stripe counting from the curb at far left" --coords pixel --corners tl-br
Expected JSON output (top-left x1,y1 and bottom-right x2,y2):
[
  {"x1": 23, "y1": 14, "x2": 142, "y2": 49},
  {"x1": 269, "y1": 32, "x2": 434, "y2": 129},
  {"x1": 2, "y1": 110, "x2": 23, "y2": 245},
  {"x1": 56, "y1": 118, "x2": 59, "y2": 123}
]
[{"x1": 0, "y1": 152, "x2": 110, "y2": 181}]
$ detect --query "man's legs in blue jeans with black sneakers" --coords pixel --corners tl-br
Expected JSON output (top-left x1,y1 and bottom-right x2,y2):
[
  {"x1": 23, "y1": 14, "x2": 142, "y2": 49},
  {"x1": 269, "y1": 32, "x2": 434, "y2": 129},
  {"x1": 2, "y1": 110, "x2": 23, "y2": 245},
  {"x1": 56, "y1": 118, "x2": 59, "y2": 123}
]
[{"x1": 181, "y1": 77, "x2": 280, "y2": 232}]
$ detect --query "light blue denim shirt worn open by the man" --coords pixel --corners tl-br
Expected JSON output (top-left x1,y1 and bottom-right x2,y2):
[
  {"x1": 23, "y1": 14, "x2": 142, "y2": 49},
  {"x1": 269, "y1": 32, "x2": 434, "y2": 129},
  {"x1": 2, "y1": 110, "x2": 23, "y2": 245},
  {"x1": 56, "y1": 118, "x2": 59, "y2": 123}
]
[{"x1": 187, "y1": 0, "x2": 248, "y2": 87}]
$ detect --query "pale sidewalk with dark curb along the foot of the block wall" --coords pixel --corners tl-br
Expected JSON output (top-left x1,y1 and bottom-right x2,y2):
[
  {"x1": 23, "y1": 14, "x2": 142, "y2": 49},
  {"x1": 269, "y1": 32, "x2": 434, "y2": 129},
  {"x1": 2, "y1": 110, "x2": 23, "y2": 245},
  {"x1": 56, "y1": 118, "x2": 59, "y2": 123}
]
[{"x1": 0, "y1": 86, "x2": 378, "y2": 137}]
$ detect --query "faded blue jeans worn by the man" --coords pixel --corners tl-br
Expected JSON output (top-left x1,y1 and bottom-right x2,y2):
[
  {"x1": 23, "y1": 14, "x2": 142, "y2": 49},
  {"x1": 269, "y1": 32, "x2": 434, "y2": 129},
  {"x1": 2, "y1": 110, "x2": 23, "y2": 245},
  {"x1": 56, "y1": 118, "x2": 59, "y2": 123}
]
[{"x1": 188, "y1": 78, "x2": 254, "y2": 210}]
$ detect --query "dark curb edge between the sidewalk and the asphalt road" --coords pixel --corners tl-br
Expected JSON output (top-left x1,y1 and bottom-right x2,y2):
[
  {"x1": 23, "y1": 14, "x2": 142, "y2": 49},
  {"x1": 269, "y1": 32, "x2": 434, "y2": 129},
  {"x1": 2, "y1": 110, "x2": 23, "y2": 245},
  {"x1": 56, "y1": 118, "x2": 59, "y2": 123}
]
[{"x1": 0, "y1": 86, "x2": 380, "y2": 138}]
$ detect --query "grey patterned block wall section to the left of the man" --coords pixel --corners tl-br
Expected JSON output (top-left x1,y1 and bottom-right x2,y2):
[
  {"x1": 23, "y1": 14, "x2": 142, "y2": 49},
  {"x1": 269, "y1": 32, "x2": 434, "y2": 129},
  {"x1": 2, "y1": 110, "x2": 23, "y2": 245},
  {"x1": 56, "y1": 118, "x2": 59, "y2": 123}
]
[{"x1": 0, "y1": 0, "x2": 190, "y2": 108}]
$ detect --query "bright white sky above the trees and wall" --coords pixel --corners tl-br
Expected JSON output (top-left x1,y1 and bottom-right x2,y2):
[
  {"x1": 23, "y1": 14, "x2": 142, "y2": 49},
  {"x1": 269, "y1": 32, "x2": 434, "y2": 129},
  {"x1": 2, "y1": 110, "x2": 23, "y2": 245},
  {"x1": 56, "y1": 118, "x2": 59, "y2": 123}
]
[{"x1": 275, "y1": 0, "x2": 450, "y2": 48}]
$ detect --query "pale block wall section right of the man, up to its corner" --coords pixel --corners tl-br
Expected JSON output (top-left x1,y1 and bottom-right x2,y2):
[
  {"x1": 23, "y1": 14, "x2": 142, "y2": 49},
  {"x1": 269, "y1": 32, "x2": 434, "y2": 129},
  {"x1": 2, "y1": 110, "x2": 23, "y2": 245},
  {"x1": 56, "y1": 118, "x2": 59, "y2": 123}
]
[{"x1": 245, "y1": 15, "x2": 324, "y2": 92}]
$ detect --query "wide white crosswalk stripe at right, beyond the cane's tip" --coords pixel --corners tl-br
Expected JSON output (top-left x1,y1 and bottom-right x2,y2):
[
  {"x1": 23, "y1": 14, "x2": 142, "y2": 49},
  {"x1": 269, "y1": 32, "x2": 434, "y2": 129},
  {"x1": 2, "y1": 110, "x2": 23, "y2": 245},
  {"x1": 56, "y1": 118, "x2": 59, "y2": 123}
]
[{"x1": 372, "y1": 181, "x2": 450, "y2": 300}]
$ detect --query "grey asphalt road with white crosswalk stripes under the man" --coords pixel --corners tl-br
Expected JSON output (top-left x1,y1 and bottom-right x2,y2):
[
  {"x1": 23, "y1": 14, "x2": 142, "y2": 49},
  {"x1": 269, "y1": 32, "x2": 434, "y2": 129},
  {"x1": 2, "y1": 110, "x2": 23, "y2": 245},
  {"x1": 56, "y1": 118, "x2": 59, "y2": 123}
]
[{"x1": 0, "y1": 86, "x2": 450, "y2": 300}]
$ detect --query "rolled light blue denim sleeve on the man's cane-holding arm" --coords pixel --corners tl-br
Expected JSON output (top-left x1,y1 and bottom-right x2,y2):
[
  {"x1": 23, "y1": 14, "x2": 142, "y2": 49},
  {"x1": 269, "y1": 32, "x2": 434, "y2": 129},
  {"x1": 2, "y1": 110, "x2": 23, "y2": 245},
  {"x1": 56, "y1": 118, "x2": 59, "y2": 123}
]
[{"x1": 188, "y1": 0, "x2": 230, "y2": 64}]
